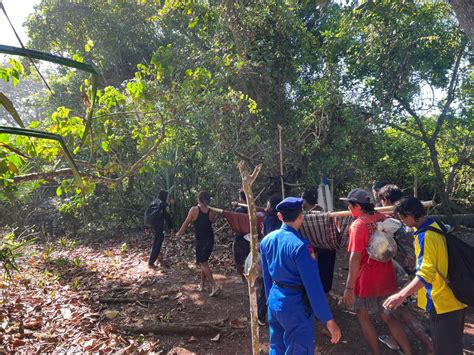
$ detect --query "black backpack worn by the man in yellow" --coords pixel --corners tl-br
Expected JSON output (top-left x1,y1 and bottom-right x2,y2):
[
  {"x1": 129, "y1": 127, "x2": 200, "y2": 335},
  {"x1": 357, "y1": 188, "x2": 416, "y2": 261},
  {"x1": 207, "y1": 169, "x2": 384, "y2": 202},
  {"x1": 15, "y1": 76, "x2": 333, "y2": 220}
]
[{"x1": 416, "y1": 221, "x2": 474, "y2": 306}]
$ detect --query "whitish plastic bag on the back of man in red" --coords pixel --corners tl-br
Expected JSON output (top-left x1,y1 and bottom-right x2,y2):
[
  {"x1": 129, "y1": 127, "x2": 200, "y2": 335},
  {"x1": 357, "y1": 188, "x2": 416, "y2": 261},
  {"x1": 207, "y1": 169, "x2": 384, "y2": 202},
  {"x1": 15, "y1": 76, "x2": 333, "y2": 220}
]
[{"x1": 367, "y1": 218, "x2": 402, "y2": 262}]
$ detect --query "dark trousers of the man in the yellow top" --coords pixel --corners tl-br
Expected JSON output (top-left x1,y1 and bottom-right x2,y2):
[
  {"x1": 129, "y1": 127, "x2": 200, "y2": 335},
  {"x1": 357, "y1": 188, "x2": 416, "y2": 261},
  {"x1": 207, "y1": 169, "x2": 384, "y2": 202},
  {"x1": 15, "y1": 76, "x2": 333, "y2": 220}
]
[{"x1": 430, "y1": 307, "x2": 466, "y2": 355}]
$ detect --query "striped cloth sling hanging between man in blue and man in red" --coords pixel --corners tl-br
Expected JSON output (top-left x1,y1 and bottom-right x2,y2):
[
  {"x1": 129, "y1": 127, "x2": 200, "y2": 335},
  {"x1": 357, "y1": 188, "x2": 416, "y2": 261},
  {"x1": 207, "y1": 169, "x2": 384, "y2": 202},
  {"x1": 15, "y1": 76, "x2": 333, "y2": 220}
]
[{"x1": 299, "y1": 213, "x2": 354, "y2": 250}]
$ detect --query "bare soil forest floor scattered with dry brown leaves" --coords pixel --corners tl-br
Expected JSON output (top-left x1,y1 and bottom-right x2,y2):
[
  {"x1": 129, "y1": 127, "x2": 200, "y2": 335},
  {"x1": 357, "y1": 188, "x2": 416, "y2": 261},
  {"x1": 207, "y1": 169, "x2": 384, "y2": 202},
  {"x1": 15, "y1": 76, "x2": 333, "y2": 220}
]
[{"x1": 0, "y1": 228, "x2": 474, "y2": 354}]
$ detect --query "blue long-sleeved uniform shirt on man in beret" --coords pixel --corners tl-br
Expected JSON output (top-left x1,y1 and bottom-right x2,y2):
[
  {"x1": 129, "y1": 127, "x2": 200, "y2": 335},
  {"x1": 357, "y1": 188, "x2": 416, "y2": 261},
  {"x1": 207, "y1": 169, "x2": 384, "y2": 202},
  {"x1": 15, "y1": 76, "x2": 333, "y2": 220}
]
[{"x1": 260, "y1": 224, "x2": 333, "y2": 323}]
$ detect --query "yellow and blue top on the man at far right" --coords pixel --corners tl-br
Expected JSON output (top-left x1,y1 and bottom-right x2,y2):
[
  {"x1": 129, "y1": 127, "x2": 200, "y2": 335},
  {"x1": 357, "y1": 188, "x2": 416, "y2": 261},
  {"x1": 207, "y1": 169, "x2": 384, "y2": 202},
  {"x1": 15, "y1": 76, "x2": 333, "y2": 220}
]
[{"x1": 414, "y1": 218, "x2": 467, "y2": 314}]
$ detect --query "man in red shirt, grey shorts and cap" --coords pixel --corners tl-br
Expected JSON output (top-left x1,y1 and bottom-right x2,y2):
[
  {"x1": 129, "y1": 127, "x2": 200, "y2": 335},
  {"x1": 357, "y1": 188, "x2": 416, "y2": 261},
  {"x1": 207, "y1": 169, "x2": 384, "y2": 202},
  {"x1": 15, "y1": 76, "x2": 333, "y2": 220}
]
[{"x1": 341, "y1": 189, "x2": 412, "y2": 355}]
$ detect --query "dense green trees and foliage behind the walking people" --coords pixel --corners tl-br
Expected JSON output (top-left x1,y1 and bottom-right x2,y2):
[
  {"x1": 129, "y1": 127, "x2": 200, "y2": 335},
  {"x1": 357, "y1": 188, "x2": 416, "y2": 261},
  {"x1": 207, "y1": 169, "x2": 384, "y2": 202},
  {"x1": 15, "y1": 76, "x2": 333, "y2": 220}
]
[{"x1": 0, "y1": 0, "x2": 473, "y2": 233}]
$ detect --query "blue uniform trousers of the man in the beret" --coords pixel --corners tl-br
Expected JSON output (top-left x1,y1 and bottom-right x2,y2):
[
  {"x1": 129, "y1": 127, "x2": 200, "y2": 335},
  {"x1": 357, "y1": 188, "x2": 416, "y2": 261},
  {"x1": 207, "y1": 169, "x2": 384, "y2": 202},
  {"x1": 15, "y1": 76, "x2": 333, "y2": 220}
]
[{"x1": 268, "y1": 298, "x2": 315, "y2": 355}]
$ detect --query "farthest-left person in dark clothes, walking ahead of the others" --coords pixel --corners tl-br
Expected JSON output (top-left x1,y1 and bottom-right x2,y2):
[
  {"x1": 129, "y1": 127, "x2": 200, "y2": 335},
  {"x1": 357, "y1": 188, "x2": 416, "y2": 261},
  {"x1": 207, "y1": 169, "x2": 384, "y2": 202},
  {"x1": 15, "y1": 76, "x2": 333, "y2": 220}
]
[{"x1": 148, "y1": 190, "x2": 173, "y2": 268}]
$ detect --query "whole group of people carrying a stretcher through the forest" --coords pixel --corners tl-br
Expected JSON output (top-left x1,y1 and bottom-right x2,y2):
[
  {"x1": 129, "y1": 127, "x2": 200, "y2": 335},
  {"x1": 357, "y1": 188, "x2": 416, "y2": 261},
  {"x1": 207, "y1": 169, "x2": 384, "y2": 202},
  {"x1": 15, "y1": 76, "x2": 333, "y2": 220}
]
[{"x1": 145, "y1": 185, "x2": 466, "y2": 355}]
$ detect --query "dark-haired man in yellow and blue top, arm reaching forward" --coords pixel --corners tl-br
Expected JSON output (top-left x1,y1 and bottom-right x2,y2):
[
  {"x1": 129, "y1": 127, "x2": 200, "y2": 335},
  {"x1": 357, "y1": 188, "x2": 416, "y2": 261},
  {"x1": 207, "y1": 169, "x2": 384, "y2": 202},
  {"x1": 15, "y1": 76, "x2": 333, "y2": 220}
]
[{"x1": 383, "y1": 197, "x2": 467, "y2": 355}]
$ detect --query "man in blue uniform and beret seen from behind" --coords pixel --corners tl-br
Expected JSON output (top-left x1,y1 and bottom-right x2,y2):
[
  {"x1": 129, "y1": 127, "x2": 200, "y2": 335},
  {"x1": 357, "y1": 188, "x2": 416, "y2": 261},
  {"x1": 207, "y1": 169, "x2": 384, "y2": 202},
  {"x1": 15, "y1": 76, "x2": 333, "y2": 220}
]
[{"x1": 260, "y1": 197, "x2": 341, "y2": 355}]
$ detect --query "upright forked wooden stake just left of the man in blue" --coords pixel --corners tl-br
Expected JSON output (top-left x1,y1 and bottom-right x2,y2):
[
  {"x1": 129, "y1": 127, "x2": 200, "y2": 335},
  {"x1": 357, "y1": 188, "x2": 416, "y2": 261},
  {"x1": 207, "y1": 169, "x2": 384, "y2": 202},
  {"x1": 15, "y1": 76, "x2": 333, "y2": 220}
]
[{"x1": 239, "y1": 160, "x2": 262, "y2": 355}]
